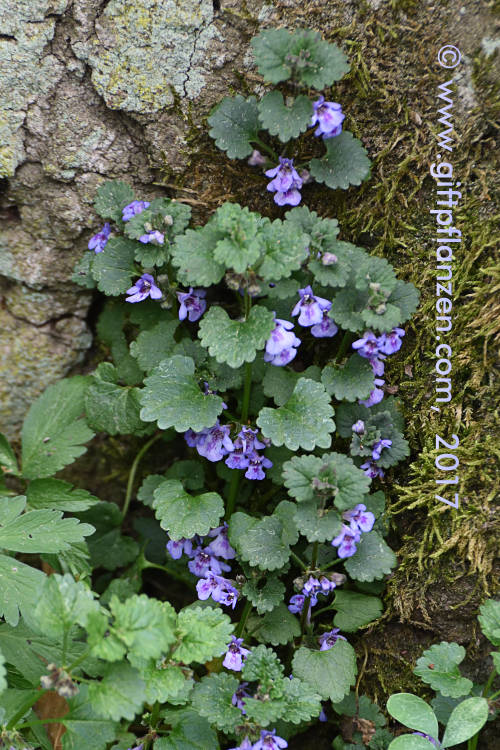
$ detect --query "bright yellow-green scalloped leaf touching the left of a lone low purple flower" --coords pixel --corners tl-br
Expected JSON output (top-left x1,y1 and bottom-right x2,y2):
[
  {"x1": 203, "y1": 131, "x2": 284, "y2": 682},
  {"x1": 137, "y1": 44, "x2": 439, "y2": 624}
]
[{"x1": 172, "y1": 607, "x2": 233, "y2": 664}]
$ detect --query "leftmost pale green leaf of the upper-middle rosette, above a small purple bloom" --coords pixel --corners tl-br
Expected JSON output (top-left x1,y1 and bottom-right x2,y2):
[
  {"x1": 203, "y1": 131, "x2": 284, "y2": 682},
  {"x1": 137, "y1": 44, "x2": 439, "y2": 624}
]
[{"x1": 172, "y1": 222, "x2": 226, "y2": 286}]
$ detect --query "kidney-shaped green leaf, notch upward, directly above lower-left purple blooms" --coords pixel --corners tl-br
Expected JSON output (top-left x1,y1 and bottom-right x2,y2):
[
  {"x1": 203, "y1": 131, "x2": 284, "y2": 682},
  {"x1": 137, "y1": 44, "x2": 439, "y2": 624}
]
[{"x1": 153, "y1": 479, "x2": 224, "y2": 540}]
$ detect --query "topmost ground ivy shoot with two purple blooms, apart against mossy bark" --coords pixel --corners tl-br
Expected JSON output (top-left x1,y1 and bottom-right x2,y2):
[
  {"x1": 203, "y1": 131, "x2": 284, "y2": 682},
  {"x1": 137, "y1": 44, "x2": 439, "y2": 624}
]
[{"x1": 208, "y1": 29, "x2": 370, "y2": 206}]
